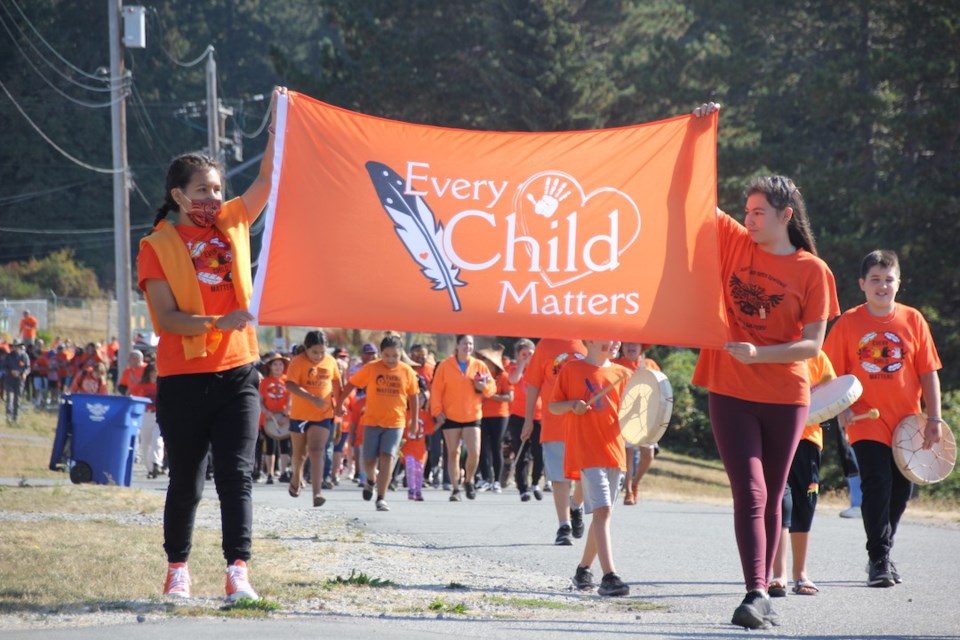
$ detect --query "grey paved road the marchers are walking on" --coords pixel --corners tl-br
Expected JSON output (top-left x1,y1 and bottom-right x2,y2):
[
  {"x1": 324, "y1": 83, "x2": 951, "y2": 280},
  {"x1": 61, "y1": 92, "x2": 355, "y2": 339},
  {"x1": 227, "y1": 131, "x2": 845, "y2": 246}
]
[{"x1": 0, "y1": 472, "x2": 960, "y2": 640}]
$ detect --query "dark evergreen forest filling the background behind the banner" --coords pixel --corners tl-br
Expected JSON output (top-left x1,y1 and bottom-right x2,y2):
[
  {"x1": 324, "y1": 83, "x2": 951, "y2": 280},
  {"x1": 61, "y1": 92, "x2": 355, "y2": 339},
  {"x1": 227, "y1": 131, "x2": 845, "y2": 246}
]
[{"x1": 0, "y1": 0, "x2": 960, "y2": 398}]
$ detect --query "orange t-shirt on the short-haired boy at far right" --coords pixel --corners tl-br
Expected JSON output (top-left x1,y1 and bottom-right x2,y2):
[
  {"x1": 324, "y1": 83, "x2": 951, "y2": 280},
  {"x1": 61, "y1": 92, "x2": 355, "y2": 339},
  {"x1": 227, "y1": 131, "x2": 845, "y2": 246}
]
[{"x1": 823, "y1": 303, "x2": 942, "y2": 446}]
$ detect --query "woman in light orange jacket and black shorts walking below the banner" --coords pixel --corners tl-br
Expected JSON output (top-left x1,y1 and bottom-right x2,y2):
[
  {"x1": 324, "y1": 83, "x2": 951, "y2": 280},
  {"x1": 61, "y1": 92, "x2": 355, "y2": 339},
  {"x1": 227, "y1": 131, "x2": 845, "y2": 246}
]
[{"x1": 430, "y1": 335, "x2": 496, "y2": 502}]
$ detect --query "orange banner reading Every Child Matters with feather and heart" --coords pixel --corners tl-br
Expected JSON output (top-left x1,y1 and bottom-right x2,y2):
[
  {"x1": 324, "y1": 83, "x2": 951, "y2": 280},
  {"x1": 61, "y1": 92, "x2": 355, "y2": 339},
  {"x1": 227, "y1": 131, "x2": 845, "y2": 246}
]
[{"x1": 252, "y1": 92, "x2": 726, "y2": 347}]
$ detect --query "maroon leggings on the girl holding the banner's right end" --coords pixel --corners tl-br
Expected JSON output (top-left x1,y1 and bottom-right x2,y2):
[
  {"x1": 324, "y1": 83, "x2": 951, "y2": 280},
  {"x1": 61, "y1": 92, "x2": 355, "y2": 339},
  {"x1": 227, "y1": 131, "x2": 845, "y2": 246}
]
[{"x1": 710, "y1": 393, "x2": 808, "y2": 591}]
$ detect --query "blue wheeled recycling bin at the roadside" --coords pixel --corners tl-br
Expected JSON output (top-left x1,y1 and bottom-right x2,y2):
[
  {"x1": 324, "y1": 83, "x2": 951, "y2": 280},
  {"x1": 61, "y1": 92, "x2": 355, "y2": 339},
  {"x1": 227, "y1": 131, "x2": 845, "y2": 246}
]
[{"x1": 62, "y1": 393, "x2": 150, "y2": 487}]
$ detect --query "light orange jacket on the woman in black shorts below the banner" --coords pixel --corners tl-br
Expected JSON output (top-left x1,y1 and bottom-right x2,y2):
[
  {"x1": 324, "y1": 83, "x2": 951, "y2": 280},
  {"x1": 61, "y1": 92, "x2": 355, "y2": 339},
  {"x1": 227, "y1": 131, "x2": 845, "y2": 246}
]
[{"x1": 430, "y1": 355, "x2": 496, "y2": 423}]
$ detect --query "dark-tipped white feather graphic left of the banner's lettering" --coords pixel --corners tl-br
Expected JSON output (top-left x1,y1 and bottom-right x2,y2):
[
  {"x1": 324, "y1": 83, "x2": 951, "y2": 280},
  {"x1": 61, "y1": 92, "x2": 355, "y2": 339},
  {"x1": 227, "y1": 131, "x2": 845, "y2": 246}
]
[{"x1": 366, "y1": 161, "x2": 467, "y2": 311}]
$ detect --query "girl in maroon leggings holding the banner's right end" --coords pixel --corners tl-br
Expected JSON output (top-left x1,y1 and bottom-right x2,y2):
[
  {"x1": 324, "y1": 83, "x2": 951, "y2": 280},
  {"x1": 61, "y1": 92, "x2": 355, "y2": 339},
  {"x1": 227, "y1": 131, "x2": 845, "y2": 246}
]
[{"x1": 693, "y1": 103, "x2": 840, "y2": 629}]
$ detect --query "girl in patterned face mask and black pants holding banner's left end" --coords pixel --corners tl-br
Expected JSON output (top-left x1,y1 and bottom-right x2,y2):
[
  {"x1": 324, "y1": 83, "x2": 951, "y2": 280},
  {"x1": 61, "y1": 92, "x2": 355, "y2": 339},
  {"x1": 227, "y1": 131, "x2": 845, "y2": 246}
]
[{"x1": 137, "y1": 87, "x2": 286, "y2": 600}]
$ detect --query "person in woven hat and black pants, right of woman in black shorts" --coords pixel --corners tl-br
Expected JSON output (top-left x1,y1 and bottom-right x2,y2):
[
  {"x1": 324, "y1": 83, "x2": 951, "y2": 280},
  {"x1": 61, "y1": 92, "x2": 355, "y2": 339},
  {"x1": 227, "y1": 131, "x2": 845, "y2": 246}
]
[{"x1": 477, "y1": 345, "x2": 513, "y2": 493}]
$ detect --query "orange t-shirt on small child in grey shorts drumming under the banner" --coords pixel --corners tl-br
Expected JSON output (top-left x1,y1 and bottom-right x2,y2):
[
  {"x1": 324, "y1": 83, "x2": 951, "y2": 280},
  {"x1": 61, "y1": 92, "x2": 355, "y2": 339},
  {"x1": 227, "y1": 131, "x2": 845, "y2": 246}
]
[{"x1": 547, "y1": 360, "x2": 630, "y2": 479}]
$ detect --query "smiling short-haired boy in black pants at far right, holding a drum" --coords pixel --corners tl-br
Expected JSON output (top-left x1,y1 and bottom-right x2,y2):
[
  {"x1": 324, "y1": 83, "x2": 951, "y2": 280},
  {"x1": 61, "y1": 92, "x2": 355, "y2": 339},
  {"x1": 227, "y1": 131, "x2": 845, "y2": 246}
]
[{"x1": 823, "y1": 249, "x2": 943, "y2": 587}]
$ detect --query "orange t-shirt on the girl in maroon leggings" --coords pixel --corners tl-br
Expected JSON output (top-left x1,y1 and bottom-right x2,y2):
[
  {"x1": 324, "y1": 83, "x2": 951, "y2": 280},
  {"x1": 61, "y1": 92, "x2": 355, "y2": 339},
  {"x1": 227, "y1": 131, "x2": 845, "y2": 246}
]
[{"x1": 693, "y1": 214, "x2": 840, "y2": 405}]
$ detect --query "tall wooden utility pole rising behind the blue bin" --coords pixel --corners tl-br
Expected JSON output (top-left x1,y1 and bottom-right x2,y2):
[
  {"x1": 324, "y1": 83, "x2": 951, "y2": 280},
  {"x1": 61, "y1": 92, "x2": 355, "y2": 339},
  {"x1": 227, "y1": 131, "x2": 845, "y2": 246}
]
[{"x1": 106, "y1": 0, "x2": 131, "y2": 370}]
